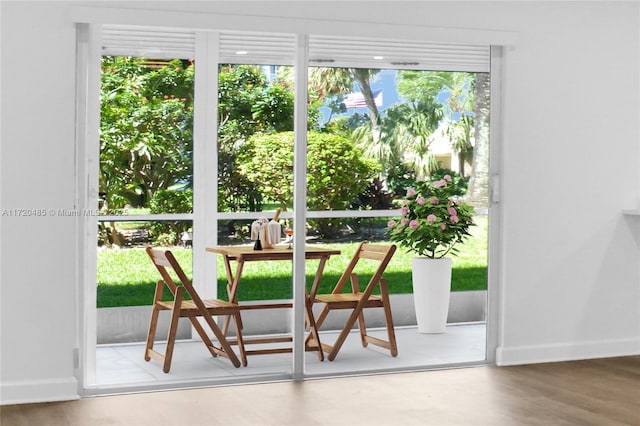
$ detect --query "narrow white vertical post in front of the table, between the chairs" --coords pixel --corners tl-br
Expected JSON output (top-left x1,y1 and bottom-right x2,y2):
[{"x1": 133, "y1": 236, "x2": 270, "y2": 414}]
[{"x1": 292, "y1": 34, "x2": 309, "y2": 381}]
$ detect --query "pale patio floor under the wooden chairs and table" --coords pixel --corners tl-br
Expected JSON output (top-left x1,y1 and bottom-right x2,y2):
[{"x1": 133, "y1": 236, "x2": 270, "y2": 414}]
[{"x1": 90, "y1": 322, "x2": 486, "y2": 394}]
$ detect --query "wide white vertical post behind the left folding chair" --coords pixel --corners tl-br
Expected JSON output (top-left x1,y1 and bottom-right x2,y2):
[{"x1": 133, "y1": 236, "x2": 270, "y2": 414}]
[{"x1": 193, "y1": 31, "x2": 218, "y2": 298}]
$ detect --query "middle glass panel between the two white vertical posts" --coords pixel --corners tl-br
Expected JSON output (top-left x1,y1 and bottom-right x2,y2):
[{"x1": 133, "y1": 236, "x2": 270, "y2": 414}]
[{"x1": 217, "y1": 59, "x2": 294, "y2": 375}]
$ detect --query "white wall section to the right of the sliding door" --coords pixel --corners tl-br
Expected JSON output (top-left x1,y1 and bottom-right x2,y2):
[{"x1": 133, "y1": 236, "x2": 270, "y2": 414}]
[{"x1": 498, "y1": 3, "x2": 640, "y2": 364}]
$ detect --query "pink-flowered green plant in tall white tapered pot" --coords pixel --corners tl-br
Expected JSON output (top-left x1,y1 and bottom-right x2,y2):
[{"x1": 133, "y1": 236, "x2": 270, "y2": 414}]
[{"x1": 387, "y1": 175, "x2": 474, "y2": 333}]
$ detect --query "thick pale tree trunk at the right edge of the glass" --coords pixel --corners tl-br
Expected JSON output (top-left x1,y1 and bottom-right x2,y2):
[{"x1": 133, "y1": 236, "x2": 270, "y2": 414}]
[{"x1": 465, "y1": 73, "x2": 491, "y2": 207}]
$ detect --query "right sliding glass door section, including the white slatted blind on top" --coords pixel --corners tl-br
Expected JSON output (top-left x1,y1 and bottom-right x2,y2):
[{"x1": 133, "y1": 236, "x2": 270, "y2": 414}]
[{"x1": 306, "y1": 36, "x2": 491, "y2": 375}]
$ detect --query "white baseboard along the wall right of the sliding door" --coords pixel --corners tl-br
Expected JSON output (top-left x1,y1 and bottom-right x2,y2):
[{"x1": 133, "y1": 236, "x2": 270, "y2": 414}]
[{"x1": 496, "y1": 338, "x2": 640, "y2": 366}]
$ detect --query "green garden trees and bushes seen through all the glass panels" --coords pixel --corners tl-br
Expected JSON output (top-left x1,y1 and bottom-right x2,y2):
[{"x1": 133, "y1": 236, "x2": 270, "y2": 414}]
[{"x1": 100, "y1": 57, "x2": 488, "y2": 245}]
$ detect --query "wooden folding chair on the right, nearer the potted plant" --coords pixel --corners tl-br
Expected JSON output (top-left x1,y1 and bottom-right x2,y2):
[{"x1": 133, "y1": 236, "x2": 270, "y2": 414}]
[{"x1": 307, "y1": 242, "x2": 398, "y2": 361}]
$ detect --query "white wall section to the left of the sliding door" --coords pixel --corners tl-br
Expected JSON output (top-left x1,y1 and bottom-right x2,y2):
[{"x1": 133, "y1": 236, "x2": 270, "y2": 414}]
[{"x1": 0, "y1": 2, "x2": 77, "y2": 402}]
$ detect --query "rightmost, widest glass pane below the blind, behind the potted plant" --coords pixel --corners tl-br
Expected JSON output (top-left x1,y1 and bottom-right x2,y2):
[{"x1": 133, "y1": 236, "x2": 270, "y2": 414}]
[{"x1": 306, "y1": 67, "x2": 489, "y2": 374}]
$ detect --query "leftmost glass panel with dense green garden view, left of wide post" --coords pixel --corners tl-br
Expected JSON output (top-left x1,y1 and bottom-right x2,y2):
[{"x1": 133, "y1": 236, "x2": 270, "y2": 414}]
[{"x1": 96, "y1": 56, "x2": 194, "y2": 343}]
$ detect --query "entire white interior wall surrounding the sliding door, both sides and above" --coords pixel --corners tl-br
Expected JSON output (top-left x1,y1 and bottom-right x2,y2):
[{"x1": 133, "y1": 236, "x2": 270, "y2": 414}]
[{"x1": 0, "y1": 1, "x2": 640, "y2": 403}]
